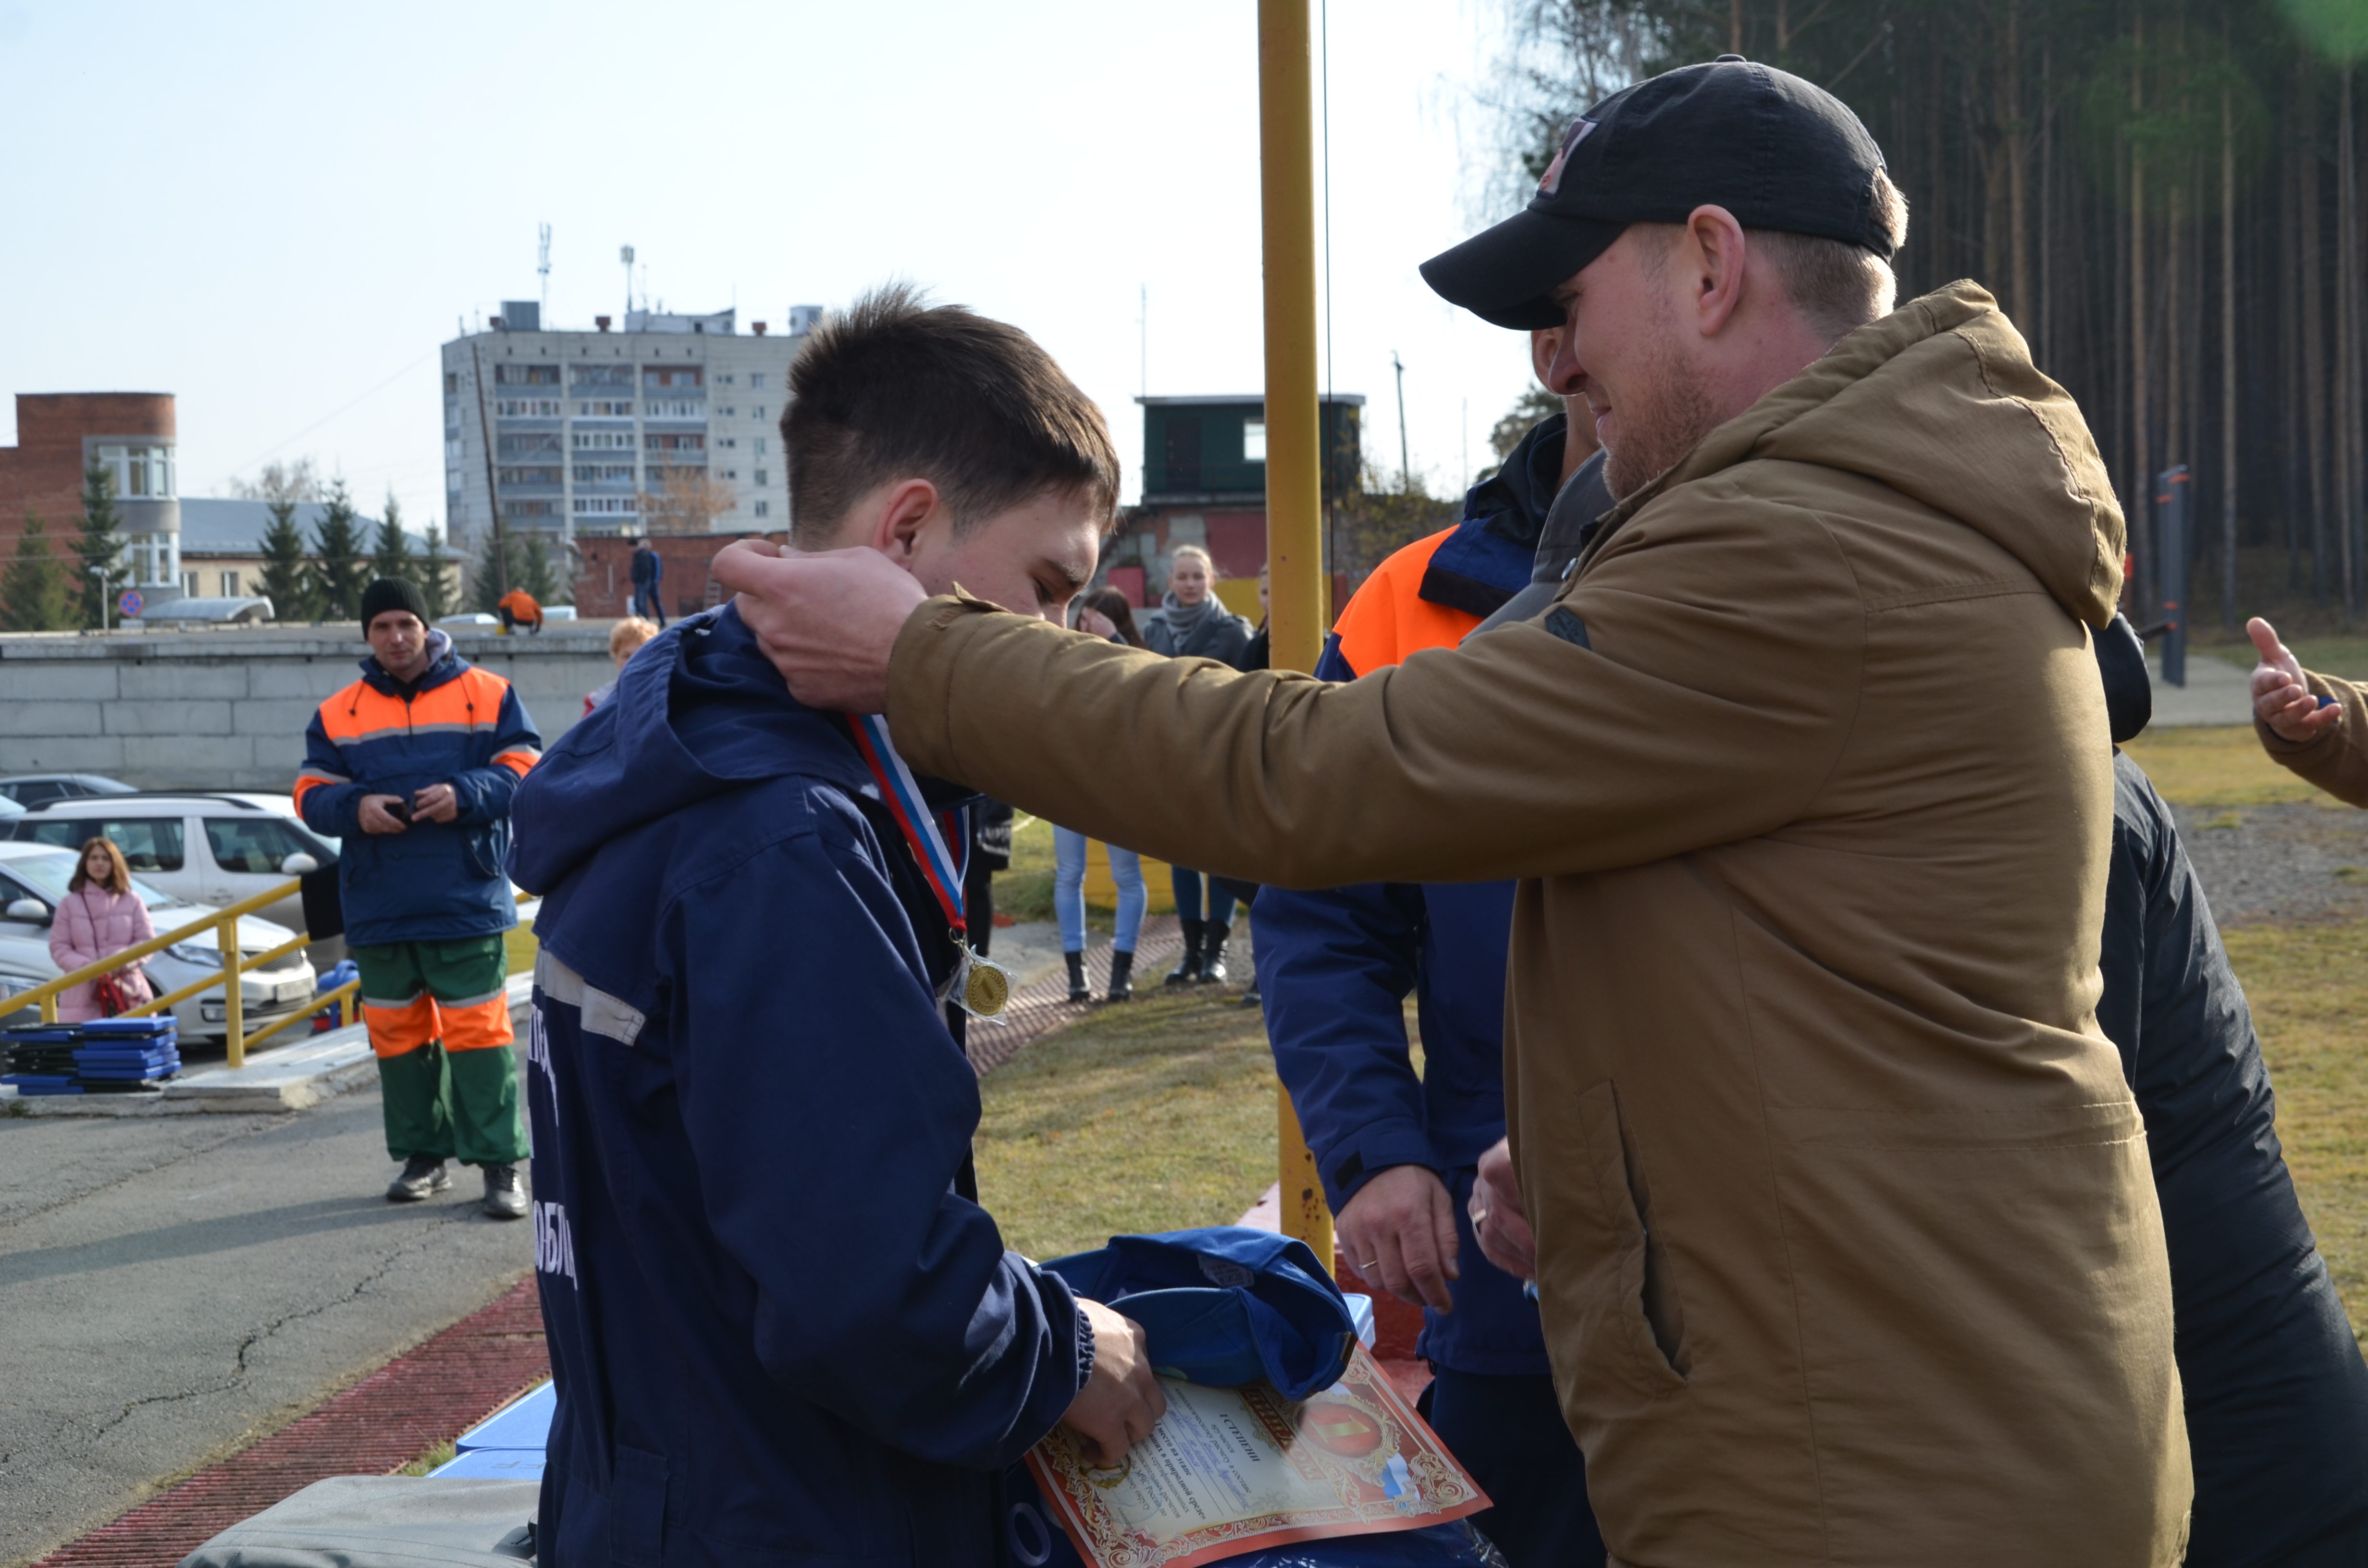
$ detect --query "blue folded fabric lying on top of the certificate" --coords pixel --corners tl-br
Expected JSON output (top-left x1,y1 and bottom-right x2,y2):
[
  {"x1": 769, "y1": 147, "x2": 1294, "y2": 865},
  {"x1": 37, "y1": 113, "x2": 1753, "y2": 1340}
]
[{"x1": 1044, "y1": 1225, "x2": 1357, "y2": 1400}]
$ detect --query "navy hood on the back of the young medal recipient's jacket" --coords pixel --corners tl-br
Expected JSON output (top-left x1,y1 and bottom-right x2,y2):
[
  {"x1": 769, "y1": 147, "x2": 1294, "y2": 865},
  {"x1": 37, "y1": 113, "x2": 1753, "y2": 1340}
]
[{"x1": 509, "y1": 604, "x2": 876, "y2": 893}]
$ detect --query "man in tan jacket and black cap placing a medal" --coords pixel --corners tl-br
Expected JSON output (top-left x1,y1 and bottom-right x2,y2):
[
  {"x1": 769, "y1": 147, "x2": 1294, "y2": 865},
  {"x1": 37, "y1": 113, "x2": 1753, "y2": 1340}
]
[{"x1": 715, "y1": 59, "x2": 2190, "y2": 1568}]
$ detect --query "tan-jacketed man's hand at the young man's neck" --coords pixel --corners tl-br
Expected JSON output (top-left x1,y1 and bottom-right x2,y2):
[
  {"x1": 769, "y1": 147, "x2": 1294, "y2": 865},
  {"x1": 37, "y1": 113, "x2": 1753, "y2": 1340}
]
[{"x1": 713, "y1": 540, "x2": 928, "y2": 713}]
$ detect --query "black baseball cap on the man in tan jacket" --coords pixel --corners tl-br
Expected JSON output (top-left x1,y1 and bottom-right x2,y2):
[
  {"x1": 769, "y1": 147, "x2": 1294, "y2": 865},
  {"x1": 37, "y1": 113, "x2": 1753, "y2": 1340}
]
[{"x1": 1423, "y1": 54, "x2": 1897, "y2": 329}]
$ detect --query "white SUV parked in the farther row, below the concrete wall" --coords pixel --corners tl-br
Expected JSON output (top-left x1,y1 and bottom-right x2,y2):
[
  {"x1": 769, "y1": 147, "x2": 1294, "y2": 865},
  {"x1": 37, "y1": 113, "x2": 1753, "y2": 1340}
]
[{"x1": 0, "y1": 791, "x2": 345, "y2": 969}]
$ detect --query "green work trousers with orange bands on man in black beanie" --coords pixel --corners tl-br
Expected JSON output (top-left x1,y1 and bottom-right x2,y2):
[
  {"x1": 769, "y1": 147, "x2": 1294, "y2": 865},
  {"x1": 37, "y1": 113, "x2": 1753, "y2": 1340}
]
[{"x1": 353, "y1": 936, "x2": 528, "y2": 1165}]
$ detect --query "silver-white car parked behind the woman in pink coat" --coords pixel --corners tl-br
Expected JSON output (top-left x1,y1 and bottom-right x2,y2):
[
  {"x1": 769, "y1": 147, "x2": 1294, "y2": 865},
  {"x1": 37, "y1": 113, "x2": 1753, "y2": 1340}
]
[{"x1": 0, "y1": 843, "x2": 317, "y2": 1044}]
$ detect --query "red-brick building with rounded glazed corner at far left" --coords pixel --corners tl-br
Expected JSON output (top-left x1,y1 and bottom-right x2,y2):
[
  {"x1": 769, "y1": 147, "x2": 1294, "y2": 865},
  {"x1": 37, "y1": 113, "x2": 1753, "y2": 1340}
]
[{"x1": 0, "y1": 393, "x2": 182, "y2": 604}]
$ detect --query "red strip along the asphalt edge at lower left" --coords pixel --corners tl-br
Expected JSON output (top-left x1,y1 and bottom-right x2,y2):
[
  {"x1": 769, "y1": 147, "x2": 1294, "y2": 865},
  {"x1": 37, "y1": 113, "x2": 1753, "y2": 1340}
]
[{"x1": 33, "y1": 1277, "x2": 552, "y2": 1568}]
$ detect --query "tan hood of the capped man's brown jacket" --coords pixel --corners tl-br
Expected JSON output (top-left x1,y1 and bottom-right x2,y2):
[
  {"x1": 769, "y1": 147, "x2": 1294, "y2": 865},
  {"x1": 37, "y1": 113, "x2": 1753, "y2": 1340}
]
[{"x1": 1605, "y1": 282, "x2": 2124, "y2": 625}]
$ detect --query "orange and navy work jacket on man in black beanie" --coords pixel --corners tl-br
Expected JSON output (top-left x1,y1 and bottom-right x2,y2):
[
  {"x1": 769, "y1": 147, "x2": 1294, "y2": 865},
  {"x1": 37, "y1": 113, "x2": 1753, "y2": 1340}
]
[{"x1": 296, "y1": 630, "x2": 543, "y2": 947}]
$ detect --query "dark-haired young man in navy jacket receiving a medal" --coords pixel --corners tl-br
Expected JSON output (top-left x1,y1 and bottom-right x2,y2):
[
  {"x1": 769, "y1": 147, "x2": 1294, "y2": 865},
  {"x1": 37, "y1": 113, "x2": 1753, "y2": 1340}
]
[{"x1": 514, "y1": 289, "x2": 1160, "y2": 1568}]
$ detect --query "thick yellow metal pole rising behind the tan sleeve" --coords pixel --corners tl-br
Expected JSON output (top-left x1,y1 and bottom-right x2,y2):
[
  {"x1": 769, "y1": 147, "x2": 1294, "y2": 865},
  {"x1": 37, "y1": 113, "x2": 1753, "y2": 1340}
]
[{"x1": 1258, "y1": 0, "x2": 1333, "y2": 1272}]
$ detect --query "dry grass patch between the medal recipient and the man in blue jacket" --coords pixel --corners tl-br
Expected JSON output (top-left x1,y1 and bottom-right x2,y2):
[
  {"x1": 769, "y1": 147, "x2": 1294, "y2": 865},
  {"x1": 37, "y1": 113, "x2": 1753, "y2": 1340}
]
[{"x1": 975, "y1": 980, "x2": 1276, "y2": 1258}]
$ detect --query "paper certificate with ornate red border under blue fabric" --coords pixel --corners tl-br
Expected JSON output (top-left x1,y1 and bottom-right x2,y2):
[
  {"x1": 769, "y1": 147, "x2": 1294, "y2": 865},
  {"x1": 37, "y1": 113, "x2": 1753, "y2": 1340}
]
[{"x1": 1028, "y1": 1346, "x2": 1490, "y2": 1568}]
